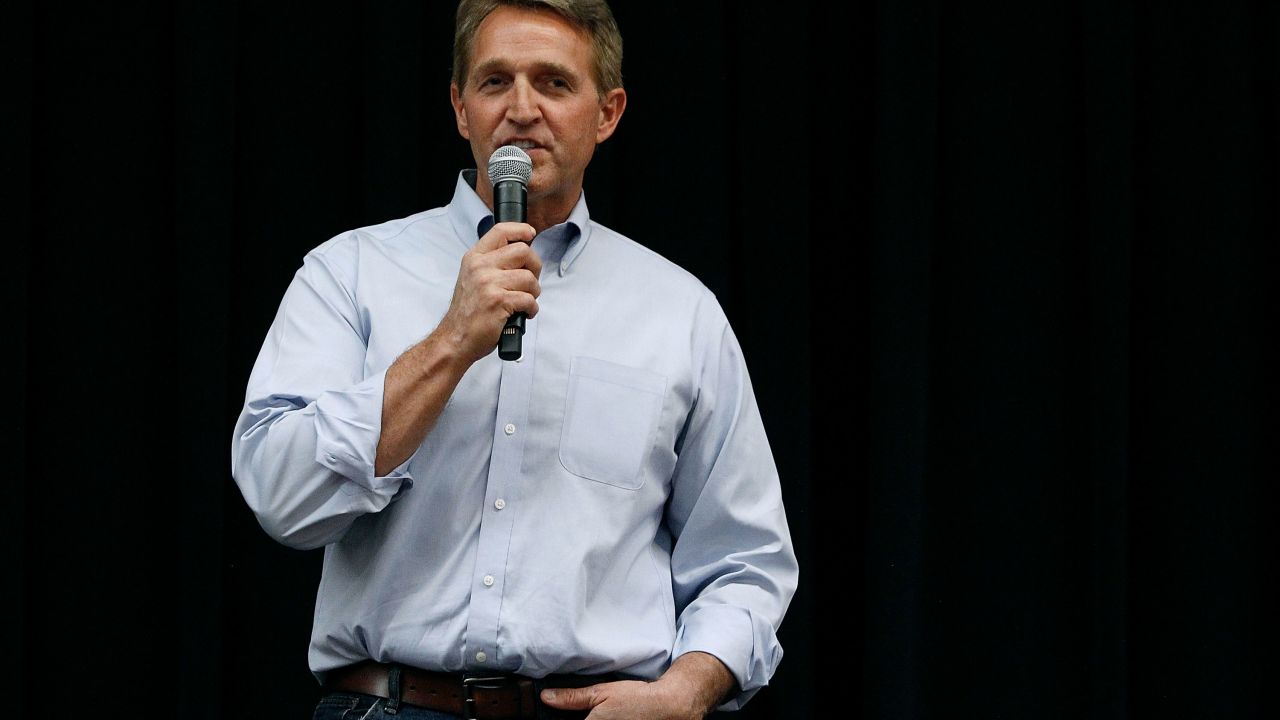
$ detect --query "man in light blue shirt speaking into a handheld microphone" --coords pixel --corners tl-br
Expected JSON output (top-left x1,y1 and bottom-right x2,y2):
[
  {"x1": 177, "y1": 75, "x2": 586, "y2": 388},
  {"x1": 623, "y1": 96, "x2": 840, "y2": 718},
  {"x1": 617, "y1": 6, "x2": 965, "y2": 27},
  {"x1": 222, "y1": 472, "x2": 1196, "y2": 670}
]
[{"x1": 233, "y1": 0, "x2": 797, "y2": 719}]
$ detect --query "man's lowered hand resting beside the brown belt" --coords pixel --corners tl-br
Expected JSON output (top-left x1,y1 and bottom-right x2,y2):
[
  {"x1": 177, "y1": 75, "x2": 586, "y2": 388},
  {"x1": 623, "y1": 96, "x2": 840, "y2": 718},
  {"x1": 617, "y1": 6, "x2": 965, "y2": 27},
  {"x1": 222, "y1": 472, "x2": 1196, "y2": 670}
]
[{"x1": 541, "y1": 652, "x2": 733, "y2": 720}]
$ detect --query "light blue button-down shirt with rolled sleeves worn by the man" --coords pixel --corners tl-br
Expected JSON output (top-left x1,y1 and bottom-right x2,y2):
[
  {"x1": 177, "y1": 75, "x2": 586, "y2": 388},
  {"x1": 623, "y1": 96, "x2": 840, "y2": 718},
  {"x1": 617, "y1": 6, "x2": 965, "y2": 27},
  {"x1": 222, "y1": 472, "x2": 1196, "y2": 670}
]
[{"x1": 232, "y1": 170, "x2": 797, "y2": 707}]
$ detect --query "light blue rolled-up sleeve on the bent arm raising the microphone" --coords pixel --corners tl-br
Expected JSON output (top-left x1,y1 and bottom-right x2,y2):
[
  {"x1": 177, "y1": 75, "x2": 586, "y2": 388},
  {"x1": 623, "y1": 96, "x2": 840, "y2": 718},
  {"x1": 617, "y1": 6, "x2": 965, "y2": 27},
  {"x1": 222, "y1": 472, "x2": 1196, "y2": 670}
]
[{"x1": 232, "y1": 238, "x2": 413, "y2": 548}]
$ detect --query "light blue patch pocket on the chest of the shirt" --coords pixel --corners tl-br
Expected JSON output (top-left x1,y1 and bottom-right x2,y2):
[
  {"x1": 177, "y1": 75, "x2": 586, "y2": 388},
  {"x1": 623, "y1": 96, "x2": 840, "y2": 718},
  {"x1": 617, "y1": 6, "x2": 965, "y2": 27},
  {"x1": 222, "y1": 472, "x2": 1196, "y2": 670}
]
[{"x1": 559, "y1": 356, "x2": 667, "y2": 489}]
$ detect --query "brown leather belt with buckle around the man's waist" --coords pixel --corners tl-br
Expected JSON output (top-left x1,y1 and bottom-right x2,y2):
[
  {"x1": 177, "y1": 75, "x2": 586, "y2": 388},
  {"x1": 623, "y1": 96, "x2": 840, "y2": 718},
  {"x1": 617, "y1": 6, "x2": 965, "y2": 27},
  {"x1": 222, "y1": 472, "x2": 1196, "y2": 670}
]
[{"x1": 325, "y1": 661, "x2": 606, "y2": 720}]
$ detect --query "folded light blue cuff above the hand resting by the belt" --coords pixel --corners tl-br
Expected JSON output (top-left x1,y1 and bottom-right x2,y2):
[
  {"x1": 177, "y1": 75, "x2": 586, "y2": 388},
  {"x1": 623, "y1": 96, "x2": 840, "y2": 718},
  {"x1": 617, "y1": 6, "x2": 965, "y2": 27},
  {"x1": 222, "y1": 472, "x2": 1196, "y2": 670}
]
[{"x1": 671, "y1": 605, "x2": 782, "y2": 710}]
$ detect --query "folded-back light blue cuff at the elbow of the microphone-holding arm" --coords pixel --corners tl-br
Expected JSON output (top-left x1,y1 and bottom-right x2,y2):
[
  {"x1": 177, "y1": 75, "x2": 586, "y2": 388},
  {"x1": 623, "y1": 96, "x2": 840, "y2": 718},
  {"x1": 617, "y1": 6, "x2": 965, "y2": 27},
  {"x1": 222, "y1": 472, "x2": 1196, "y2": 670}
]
[{"x1": 315, "y1": 370, "x2": 417, "y2": 496}]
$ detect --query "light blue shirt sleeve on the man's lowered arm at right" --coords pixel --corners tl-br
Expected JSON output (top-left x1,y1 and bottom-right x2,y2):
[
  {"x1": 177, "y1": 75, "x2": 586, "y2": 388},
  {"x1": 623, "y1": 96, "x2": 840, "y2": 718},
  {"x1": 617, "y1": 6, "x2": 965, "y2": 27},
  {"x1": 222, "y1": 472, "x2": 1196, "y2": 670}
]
[{"x1": 667, "y1": 295, "x2": 799, "y2": 710}]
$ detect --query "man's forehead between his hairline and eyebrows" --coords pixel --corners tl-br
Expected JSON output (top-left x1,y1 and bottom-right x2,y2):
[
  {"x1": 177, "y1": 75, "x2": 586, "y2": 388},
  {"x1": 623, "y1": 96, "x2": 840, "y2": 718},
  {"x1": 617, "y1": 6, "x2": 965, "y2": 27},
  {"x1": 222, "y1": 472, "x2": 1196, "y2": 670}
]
[{"x1": 471, "y1": 5, "x2": 591, "y2": 76}]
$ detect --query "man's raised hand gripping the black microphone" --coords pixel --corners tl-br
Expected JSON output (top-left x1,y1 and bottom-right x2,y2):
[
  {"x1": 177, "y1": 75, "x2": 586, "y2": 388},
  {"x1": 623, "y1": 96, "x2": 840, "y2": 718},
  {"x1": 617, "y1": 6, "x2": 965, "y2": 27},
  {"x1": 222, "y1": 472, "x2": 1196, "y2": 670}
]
[{"x1": 433, "y1": 223, "x2": 543, "y2": 364}]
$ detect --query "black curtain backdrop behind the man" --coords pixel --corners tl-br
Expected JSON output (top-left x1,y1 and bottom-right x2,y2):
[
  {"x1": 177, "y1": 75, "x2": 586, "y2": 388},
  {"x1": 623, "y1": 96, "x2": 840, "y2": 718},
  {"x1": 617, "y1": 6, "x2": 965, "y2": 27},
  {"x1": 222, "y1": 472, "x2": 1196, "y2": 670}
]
[{"x1": 12, "y1": 0, "x2": 1280, "y2": 719}]
